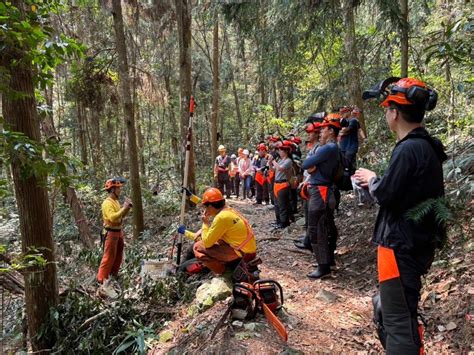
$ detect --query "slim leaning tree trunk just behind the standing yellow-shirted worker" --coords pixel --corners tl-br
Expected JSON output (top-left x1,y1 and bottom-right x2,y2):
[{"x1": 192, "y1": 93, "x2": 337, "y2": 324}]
[{"x1": 112, "y1": 0, "x2": 144, "y2": 239}]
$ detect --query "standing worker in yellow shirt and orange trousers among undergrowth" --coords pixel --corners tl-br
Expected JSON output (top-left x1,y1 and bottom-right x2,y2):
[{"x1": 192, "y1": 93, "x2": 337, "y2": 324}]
[{"x1": 97, "y1": 178, "x2": 132, "y2": 298}]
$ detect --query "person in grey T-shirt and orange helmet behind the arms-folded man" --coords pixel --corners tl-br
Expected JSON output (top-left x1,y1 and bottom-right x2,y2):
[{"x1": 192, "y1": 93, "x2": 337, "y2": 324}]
[{"x1": 269, "y1": 140, "x2": 294, "y2": 229}]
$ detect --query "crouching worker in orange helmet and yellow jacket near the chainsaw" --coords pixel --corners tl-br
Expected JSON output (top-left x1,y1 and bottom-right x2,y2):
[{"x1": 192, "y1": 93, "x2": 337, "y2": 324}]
[{"x1": 178, "y1": 187, "x2": 257, "y2": 275}]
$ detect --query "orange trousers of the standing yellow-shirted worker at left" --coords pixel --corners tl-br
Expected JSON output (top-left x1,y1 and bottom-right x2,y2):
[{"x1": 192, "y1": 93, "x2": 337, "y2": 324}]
[{"x1": 97, "y1": 231, "x2": 125, "y2": 283}]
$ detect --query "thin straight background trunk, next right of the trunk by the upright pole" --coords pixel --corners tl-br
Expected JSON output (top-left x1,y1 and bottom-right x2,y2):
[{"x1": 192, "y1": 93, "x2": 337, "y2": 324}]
[{"x1": 210, "y1": 10, "x2": 220, "y2": 166}]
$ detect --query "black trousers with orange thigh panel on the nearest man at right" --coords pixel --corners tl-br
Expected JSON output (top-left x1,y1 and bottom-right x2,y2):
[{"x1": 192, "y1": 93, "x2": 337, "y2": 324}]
[{"x1": 377, "y1": 246, "x2": 434, "y2": 355}]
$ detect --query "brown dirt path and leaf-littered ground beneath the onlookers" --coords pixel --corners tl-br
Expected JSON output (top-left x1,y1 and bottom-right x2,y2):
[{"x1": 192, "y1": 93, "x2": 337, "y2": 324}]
[{"x1": 150, "y1": 194, "x2": 474, "y2": 354}]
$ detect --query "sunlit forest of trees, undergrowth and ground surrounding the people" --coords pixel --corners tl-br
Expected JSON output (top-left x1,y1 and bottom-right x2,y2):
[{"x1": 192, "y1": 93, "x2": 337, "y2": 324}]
[{"x1": 0, "y1": 0, "x2": 474, "y2": 354}]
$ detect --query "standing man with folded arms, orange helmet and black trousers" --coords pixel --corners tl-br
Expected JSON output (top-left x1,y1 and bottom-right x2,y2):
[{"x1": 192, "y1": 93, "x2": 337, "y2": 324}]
[{"x1": 302, "y1": 114, "x2": 341, "y2": 279}]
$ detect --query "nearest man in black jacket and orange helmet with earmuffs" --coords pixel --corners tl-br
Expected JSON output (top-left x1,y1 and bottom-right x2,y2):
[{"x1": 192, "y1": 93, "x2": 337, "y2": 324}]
[{"x1": 355, "y1": 78, "x2": 446, "y2": 354}]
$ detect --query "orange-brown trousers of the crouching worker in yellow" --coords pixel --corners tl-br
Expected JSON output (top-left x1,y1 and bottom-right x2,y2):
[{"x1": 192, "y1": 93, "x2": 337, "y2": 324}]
[{"x1": 193, "y1": 240, "x2": 240, "y2": 275}]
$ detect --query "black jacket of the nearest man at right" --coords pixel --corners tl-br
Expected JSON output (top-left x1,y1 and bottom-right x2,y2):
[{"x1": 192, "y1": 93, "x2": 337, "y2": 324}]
[{"x1": 369, "y1": 127, "x2": 447, "y2": 251}]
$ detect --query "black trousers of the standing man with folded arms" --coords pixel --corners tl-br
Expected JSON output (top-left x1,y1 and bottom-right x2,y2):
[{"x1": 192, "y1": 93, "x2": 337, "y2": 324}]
[{"x1": 308, "y1": 185, "x2": 337, "y2": 265}]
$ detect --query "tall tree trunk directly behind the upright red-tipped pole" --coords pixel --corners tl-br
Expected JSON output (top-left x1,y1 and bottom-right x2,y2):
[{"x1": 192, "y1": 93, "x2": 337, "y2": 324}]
[{"x1": 175, "y1": 0, "x2": 196, "y2": 191}]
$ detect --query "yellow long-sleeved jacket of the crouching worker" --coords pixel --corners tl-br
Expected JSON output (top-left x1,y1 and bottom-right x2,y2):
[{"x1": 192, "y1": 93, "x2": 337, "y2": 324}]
[{"x1": 185, "y1": 207, "x2": 257, "y2": 254}]
